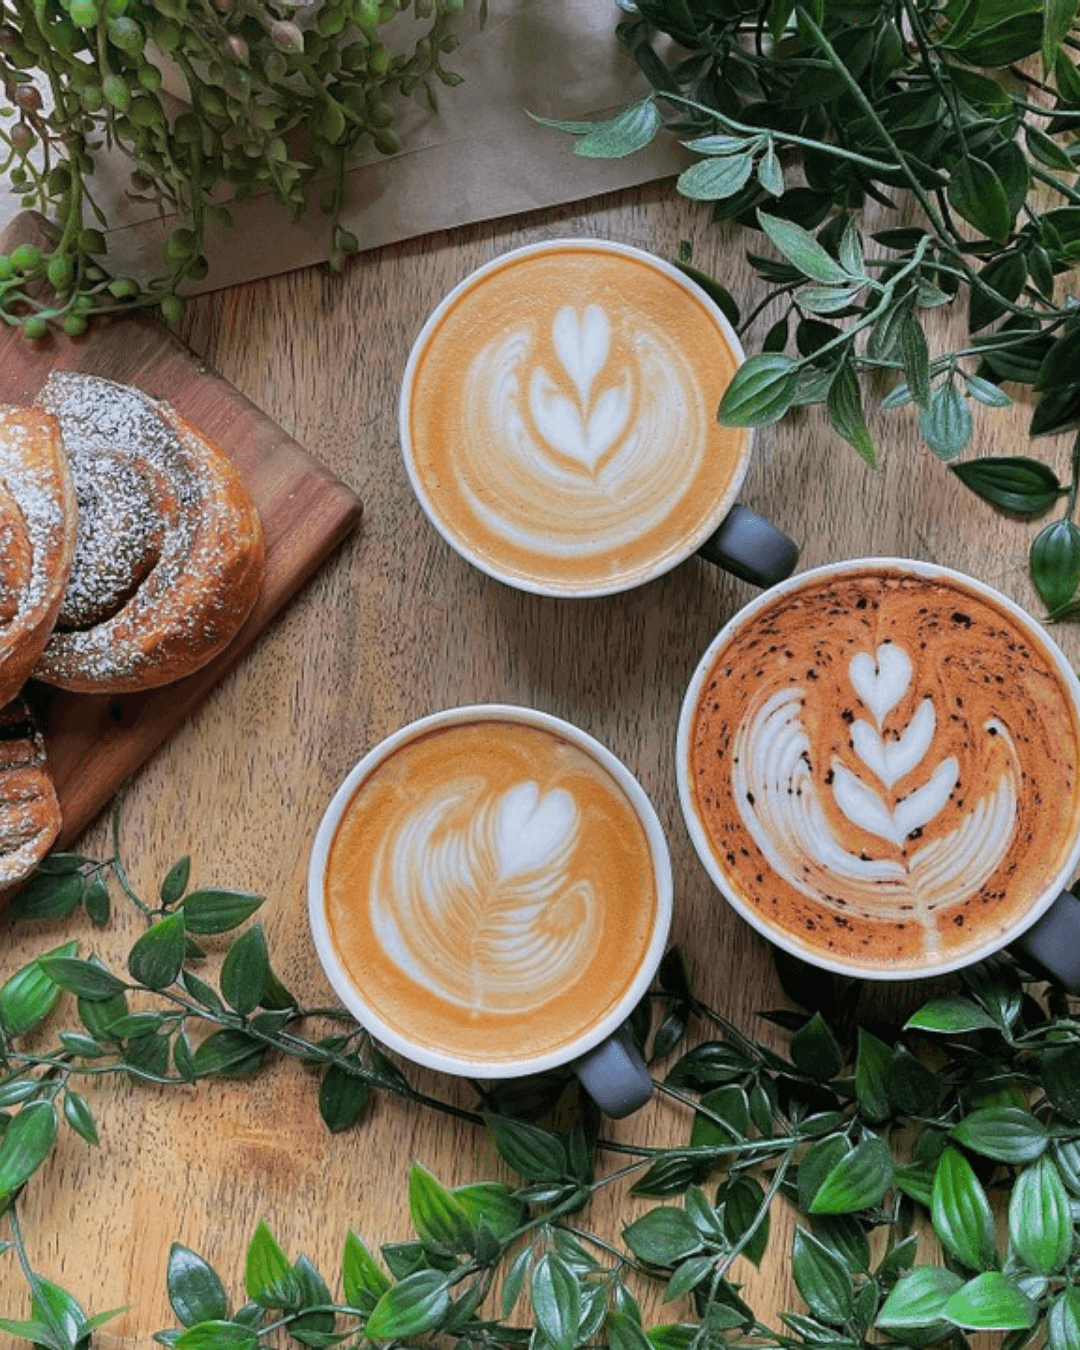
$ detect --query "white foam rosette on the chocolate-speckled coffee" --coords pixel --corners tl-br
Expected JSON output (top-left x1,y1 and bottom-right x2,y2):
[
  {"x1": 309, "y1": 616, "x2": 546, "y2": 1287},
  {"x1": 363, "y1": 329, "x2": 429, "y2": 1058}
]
[{"x1": 733, "y1": 643, "x2": 1021, "y2": 952}]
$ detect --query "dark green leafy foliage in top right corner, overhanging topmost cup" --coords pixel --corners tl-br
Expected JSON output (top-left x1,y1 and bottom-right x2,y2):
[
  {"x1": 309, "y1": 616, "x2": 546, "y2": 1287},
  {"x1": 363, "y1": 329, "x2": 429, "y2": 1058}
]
[{"x1": 541, "y1": 0, "x2": 1080, "y2": 618}]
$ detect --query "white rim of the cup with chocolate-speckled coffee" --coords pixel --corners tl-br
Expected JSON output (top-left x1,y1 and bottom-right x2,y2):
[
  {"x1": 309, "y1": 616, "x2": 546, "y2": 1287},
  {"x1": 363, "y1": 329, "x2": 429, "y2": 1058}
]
[{"x1": 675, "y1": 558, "x2": 1080, "y2": 981}]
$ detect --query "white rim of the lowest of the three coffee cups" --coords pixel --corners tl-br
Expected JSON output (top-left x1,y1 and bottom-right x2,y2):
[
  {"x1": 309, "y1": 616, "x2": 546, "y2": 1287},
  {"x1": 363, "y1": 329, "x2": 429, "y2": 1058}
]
[{"x1": 308, "y1": 703, "x2": 674, "y2": 1079}]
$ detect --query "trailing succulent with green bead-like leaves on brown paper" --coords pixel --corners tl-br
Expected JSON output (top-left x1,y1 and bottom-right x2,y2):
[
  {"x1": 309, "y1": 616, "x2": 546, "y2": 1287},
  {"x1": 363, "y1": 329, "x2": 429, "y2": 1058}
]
[{"x1": 0, "y1": 0, "x2": 464, "y2": 330}]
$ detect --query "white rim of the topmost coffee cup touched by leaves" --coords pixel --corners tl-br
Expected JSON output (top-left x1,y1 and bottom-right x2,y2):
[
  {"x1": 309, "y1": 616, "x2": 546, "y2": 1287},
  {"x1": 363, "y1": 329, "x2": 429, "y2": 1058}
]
[{"x1": 398, "y1": 235, "x2": 753, "y2": 599}]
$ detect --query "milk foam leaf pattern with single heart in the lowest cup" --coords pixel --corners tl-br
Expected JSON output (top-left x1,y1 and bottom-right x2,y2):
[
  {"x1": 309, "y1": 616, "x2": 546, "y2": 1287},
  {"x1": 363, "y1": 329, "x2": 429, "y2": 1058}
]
[{"x1": 369, "y1": 780, "x2": 599, "y2": 1013}]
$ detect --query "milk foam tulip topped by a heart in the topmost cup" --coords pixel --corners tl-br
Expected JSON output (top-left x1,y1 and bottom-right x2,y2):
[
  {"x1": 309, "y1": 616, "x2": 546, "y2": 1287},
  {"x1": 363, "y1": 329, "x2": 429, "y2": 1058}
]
[{"x1": 458, "y1": 304, "x2": 710, "y2": 558}]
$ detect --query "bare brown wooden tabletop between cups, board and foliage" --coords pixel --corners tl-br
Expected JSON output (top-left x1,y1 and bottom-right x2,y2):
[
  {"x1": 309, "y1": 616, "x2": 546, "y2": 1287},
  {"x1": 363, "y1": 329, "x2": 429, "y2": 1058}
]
[{"x1": 0, "y1": 184, "x2": 1080, "y2": 1345}]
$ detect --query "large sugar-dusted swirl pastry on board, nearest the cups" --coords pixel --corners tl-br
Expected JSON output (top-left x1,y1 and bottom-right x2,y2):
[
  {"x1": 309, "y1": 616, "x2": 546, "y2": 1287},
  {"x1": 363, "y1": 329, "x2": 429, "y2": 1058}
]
[{"x1": 34, "y1": 371, "x2": 265, "y2": 693}]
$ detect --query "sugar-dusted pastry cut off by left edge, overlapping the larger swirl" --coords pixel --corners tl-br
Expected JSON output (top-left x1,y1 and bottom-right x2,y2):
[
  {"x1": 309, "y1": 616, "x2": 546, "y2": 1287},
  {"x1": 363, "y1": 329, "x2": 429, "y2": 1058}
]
[{"x1": 0, "y1": 406, "x2": 76, "y2": 706}]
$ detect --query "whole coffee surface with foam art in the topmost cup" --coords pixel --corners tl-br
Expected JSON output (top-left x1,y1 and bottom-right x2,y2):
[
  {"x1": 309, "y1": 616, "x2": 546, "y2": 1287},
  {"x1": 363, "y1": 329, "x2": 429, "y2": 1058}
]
[{"x1": 404, "y1": 246, "x2": 749, "y2": 594}]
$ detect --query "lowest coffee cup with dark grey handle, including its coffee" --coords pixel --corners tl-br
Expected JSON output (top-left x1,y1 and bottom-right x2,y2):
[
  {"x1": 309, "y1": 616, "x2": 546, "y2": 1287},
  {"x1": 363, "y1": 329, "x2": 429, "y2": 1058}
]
[{"x1": 308, "y1": 703, "x2": 672, "y2": 1115}]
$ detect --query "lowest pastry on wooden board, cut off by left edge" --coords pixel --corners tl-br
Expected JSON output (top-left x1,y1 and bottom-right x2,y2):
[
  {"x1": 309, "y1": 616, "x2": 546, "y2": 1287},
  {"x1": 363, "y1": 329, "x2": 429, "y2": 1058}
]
[{"x1": 0, "y1": 698, "x2": 61, "y2": 894}]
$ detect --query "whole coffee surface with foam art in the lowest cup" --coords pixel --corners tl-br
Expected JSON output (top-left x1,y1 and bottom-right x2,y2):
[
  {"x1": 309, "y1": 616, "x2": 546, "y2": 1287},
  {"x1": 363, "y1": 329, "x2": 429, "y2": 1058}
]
[{"x1": 324, "y1": 721, "x2": 657, "y2": 1062}]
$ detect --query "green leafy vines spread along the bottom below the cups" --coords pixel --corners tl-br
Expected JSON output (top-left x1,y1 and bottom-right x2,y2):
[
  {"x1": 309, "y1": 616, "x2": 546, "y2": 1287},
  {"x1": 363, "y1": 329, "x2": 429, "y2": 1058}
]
[{"x1": 0, "y1": 831, "x2": 1080, "y2": 1350}]
